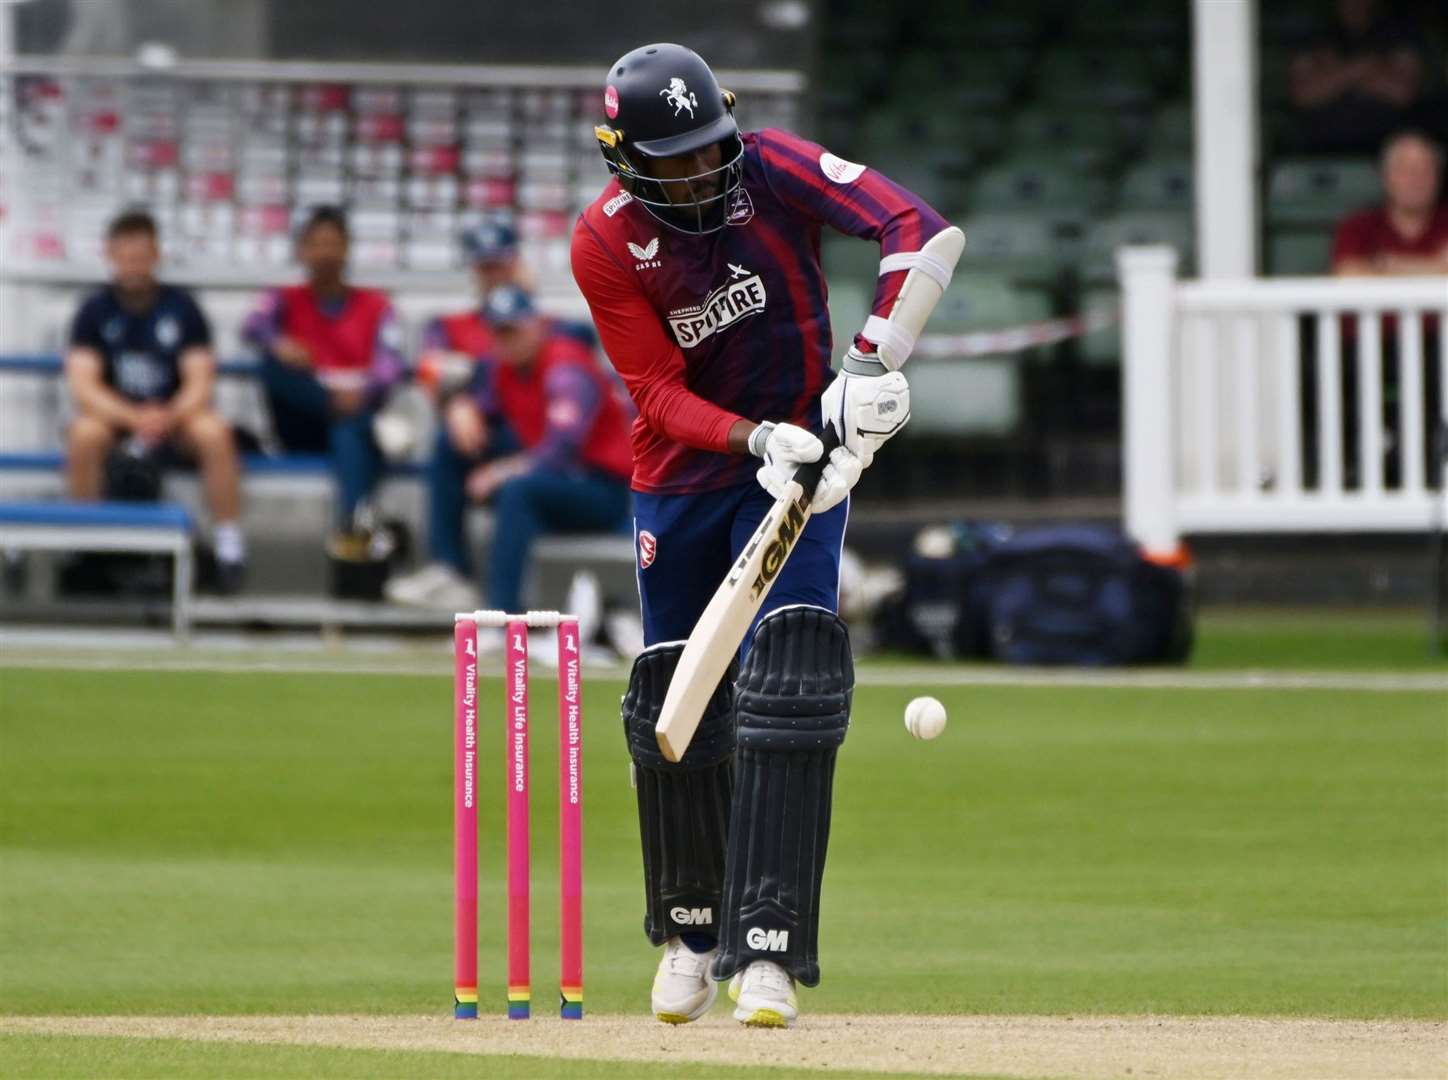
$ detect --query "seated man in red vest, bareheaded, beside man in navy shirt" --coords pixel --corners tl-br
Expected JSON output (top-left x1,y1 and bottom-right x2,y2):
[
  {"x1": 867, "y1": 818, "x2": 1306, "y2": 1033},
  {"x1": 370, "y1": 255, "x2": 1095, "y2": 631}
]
[{"x1": 242, "y1": 207, "x2": 405, "y2": 530}]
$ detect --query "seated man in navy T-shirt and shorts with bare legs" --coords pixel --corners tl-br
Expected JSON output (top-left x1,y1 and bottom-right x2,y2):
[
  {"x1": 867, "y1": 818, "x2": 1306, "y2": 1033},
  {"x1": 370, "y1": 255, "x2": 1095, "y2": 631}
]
[{"x1": 65, "y1": 210, "x2": 246, "y2": 592}]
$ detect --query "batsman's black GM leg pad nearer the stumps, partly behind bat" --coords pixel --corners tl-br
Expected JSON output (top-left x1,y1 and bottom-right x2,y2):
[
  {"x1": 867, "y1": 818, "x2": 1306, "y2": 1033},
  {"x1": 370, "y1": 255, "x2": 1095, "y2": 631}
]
[{"x1": 623, "y1": 641, "x2": 734, "y2": 945}]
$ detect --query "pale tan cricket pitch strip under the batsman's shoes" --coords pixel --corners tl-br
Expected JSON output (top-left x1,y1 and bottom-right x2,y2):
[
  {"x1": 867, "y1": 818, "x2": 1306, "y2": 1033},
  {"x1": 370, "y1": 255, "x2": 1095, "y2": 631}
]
[{"x1": 0, "y1": 1009, "x2": 1448, "y2": 1080}]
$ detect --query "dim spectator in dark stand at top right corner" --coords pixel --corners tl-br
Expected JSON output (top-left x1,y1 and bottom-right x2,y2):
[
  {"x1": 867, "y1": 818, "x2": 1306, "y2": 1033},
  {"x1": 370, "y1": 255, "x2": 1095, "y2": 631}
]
[{"x1": 1290, "y1": 0, "x2": 1428, "y2": 153}]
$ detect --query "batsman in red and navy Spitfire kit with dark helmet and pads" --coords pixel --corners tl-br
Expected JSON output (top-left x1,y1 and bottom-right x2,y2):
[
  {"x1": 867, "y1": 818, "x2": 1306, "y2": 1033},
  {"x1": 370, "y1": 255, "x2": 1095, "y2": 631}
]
[{"x1": 572, "y1": 45, "x2": 959, "y2": 1026}]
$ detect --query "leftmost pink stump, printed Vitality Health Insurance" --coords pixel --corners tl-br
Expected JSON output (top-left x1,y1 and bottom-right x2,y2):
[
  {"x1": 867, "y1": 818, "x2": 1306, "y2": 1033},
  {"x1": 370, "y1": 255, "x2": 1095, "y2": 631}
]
[{"x1": 453, "y1": 620, "x2": 478, "y2": 1021}]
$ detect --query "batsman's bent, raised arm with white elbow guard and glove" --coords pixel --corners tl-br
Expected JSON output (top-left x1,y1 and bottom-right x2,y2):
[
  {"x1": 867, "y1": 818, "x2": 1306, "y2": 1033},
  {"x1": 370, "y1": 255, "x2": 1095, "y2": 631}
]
[{"x1": 759, "y1": 130, "x2": 960, "y2": 511}]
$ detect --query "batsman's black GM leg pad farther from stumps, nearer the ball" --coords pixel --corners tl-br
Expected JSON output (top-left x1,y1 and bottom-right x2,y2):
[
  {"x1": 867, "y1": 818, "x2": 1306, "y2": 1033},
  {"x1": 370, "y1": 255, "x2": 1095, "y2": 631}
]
[{"x1": 714, "y1": 605, "x2": 854, "y2": 986}]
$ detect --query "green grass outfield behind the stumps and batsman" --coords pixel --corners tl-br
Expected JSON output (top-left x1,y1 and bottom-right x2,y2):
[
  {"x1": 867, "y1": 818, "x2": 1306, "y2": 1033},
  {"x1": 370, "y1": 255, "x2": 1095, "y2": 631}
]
[{"x1": 0, "y1": 610, "x2": 1448, "y2": 1076}]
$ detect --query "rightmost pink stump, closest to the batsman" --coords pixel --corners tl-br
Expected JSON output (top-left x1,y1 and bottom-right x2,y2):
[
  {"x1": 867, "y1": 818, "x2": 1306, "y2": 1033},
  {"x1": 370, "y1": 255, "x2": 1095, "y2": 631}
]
[{"x1": 557, "y1": 620, "x2": 584, "y2": 1021}]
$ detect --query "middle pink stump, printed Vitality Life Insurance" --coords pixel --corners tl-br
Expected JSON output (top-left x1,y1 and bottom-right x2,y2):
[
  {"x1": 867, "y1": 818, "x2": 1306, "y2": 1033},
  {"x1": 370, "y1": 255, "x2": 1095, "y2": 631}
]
[{"x1": 504, "y1": 620, "x2": 531, "y2": 1021}]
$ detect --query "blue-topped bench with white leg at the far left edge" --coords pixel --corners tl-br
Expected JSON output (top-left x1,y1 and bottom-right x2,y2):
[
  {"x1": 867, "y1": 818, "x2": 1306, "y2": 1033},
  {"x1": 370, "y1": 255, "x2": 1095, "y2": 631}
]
[{"x1": 0, "y1": 502, "x2": 194, "y2": 640}]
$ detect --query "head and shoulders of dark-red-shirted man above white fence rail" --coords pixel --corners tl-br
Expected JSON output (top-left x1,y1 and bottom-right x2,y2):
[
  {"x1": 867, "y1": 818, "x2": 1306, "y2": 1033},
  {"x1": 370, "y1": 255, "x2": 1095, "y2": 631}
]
[{"x1": 1332, "y1": 132, "x2": 1448, "y2": 275}]
